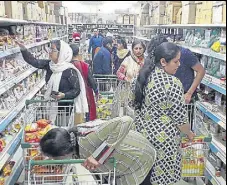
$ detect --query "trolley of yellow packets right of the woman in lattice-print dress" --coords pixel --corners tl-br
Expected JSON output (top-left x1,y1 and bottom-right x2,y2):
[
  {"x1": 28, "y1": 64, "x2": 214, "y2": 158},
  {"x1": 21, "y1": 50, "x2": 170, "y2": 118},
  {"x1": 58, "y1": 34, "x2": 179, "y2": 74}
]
[{"x1": 181, "y1": 104, "x2": 212, "y2": 178}]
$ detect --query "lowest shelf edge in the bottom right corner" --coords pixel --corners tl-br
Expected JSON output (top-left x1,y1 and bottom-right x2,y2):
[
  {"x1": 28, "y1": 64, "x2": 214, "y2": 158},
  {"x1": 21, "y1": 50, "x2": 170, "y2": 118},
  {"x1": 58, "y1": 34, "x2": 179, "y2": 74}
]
[{"x1": 206, "y1": 161, "x2": 226, "y2": 185}]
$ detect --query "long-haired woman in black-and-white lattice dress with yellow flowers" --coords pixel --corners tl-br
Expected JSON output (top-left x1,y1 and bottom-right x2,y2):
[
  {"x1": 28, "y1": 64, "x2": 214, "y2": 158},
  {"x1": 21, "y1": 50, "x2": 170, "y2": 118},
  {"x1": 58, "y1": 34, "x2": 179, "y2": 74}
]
[{"x1": 130, "y1": 40, "x2": 194, "y2": 185}]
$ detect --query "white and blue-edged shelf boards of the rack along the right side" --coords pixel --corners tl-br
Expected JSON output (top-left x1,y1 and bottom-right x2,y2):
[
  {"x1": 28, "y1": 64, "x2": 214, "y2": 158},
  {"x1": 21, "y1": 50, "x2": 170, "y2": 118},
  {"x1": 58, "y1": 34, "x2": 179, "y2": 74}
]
[{"x1": 134, "y1": 24, "x2": 226, "y2": 185}]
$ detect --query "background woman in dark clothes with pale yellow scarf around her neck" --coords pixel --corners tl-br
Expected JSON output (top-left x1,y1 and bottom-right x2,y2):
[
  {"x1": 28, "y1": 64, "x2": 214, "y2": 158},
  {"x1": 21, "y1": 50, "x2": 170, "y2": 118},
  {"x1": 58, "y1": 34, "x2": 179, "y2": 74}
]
[{"x1": 113, "y1": 39, "x2": 130, "y2": 74}]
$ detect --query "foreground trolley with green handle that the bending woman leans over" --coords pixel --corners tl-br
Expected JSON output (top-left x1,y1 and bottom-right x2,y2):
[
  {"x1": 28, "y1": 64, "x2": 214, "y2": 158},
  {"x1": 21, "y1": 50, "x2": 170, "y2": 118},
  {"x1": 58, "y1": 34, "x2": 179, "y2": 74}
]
[{"x1": 28, "y1": 158, "x2": 116, "y2": 185}]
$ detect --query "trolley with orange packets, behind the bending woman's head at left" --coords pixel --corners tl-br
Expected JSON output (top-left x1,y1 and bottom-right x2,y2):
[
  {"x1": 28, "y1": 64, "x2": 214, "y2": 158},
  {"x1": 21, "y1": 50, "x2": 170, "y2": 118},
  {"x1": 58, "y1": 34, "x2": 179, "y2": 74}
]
[{"x1": 21, "y1": 100, "x2": 75, "y2": 181}]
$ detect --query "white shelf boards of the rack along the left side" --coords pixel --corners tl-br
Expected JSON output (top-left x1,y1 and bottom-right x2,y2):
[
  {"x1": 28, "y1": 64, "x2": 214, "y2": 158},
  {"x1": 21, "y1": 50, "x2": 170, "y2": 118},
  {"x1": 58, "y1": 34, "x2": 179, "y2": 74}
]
[{"x1": 0, "y1": 14, "x2": 68, "y2": 185}]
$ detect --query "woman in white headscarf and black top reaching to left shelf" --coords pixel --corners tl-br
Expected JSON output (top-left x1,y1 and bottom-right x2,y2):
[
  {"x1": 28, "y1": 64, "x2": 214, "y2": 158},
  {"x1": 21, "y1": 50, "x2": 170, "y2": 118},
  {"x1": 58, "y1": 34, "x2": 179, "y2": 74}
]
[{"x1": 17, "y1": 40, "x2": 88, "y2": 123}]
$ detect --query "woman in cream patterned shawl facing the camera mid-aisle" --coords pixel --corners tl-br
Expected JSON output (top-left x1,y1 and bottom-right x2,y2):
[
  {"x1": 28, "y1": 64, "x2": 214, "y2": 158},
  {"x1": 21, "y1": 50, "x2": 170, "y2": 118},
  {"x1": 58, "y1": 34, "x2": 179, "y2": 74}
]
[{"x1": 117, "y1": 40, "x2": 146, "y2": 82}]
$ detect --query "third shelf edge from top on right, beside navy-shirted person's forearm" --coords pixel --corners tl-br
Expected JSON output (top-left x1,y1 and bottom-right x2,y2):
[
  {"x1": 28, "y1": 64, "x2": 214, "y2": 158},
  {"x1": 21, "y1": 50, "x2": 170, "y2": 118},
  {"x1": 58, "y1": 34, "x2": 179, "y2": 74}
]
[{"x1": 202, "y1": 74, "x2": 226, "y2": 95}]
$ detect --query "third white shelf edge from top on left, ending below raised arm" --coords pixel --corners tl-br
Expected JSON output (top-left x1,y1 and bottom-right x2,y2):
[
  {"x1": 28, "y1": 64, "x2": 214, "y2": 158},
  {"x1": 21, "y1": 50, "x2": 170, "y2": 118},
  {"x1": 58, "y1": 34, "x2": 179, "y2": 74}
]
[{"x1": 0, "y1": 67, "x2": 38, "y2": 95}]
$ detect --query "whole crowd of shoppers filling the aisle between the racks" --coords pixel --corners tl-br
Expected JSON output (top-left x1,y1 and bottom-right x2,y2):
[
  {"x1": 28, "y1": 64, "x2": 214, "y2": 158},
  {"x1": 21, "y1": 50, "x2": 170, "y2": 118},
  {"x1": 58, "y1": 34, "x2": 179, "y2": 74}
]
[{"x1": 17, "y1": 29, "x2": 205, "y2": 185}]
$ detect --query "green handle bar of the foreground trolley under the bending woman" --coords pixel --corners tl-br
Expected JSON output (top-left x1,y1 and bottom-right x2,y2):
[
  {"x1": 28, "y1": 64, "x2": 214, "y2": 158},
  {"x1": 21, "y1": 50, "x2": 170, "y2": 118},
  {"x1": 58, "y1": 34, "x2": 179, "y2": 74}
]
[{"x1": 30, "y1": 158, "x2": 116, "y2": 166}]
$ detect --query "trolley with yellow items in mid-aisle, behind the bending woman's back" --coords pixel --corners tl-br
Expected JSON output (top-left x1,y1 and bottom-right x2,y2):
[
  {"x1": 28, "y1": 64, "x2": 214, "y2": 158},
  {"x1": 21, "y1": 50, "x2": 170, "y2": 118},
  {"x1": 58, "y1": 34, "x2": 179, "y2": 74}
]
[{"x1": 94, "y1": 75, "x2": 118, "y2": 119}]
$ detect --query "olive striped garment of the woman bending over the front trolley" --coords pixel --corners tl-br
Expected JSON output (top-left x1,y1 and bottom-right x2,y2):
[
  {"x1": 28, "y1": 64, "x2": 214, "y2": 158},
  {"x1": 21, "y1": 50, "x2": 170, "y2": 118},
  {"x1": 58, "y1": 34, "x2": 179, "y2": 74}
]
[{"x1": 76, "y1": 116, "x2": 156, "y2": 185}]
